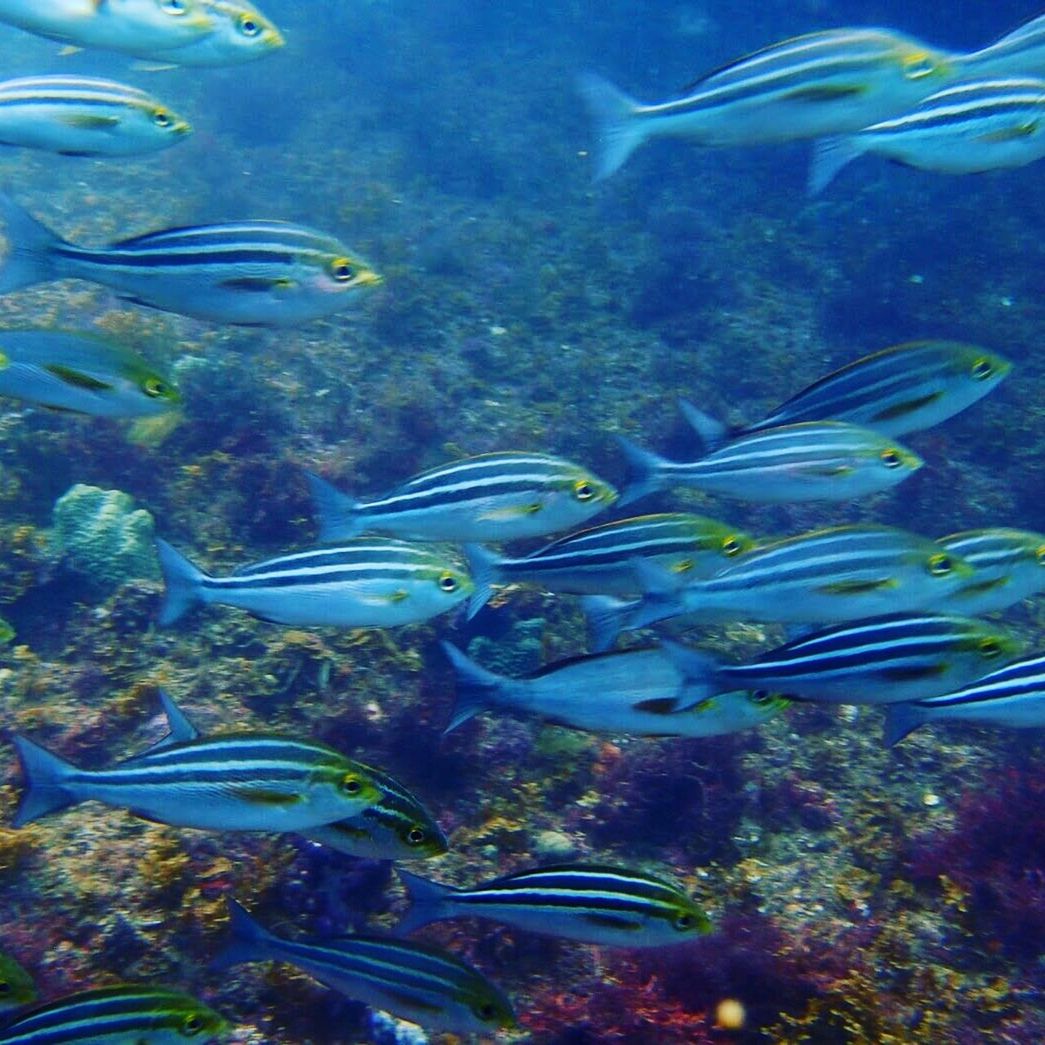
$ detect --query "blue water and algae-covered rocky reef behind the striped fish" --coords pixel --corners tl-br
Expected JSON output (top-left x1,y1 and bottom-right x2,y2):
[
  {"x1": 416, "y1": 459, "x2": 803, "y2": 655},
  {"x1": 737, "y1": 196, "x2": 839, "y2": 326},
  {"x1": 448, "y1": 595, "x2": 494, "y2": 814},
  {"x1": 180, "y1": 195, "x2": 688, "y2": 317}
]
[{"x1": 0, "y1": 0, "x2": 1045, "y2": 1045}]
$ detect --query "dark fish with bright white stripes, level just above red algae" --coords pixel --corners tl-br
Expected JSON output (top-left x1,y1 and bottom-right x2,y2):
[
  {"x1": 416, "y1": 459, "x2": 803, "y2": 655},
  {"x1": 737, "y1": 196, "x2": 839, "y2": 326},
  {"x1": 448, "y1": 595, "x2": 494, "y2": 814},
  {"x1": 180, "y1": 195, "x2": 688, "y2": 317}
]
[{"x1": 396, "y1": 863, "x2": 712, "y2": 948}]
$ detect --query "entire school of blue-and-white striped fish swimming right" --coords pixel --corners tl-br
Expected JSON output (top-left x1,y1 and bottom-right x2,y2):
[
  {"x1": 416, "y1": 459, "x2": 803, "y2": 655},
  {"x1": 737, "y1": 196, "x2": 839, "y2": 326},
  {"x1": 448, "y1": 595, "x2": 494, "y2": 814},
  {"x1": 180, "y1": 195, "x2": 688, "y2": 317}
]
[{"x1": 0, "y1": 0, "x2": 1045, "y2": 1045}]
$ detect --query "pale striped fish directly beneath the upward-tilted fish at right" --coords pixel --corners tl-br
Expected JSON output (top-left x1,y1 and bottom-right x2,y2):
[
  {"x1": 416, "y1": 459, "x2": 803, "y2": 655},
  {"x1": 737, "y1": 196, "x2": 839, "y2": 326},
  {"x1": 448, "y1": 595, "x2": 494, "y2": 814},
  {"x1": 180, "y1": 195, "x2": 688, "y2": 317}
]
[{"x1": 617, "y1": 420, "x2": 925, "y2": 505}]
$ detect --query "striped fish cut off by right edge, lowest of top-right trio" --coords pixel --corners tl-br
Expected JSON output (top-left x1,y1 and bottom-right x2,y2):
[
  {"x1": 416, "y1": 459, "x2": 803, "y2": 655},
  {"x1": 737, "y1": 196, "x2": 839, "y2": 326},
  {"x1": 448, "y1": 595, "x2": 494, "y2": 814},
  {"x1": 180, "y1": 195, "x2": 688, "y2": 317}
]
[{"x1": 808, "y1": 77, "x2": 1045, "y2": 195}]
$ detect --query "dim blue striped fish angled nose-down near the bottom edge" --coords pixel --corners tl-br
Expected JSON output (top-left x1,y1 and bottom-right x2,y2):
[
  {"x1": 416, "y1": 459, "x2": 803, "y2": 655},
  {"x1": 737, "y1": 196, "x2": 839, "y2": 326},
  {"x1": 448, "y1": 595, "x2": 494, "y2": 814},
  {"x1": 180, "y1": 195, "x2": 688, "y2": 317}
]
[{"x1": 211, "y1": 898, "x2": 515, "y2": 1034}]
